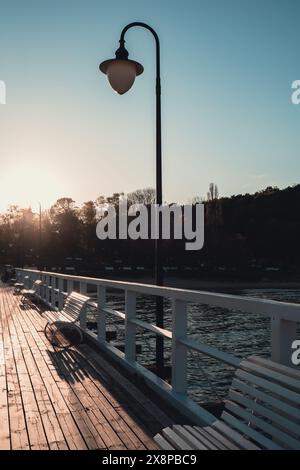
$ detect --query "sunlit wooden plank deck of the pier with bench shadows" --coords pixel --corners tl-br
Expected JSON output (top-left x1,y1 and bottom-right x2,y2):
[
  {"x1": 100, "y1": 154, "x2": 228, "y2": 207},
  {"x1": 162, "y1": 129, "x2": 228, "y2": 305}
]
[{"x1": 0, "y1": 286, "x2": 173, "y2": 450}]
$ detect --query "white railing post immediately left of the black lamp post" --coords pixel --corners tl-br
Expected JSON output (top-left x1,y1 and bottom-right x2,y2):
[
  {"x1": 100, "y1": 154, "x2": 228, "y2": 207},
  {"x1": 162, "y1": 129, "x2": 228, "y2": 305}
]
[{"x1": 125, "y1": 290, "x2": 136, "y2": 362}]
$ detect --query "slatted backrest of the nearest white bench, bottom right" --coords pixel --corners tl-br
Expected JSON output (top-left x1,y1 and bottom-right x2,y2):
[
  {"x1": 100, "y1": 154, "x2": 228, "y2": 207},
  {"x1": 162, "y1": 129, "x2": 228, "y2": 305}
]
[{"x1": 221, "y1": 356, "x2": 300, "y2": 449}]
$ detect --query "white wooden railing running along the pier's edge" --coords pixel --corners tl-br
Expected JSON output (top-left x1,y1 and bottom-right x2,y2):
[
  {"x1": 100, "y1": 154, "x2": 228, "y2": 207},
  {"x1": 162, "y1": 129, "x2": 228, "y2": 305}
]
[{"x1": 16, "y1": 269, "x2": 300, "y2": 424}]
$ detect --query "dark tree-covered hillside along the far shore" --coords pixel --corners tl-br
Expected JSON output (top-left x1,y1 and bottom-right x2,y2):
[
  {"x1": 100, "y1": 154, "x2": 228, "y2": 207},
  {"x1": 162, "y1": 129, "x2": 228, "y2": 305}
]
[{"x1": 0, "y1": 183, "x2": 300, "y2": 278}]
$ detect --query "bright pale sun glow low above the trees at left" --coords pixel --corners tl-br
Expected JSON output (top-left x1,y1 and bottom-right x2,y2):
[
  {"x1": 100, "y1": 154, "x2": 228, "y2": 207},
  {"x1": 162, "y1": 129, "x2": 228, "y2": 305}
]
[{"x1": 0, "y1": 162, "x2": 64, "y2": 212}]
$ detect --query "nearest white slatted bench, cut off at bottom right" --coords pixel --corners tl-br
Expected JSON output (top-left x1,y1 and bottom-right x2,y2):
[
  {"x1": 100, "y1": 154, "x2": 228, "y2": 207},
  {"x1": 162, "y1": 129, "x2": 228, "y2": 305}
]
[{"x1": 154, "y1": 356, "x2": 300, "y2": 450}]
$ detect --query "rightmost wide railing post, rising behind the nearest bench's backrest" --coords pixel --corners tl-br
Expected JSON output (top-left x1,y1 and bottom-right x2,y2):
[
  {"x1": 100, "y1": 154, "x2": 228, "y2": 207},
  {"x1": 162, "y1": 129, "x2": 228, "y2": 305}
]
[{"x1": 271, "y1": 317, "x2": 297, "y2": 367}]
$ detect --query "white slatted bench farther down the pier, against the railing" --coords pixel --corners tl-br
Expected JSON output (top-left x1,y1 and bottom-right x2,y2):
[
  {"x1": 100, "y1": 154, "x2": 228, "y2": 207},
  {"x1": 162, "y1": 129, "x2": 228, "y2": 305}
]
[{"x1": 44, "y1": 291, "x2": 90, "y2": 347}]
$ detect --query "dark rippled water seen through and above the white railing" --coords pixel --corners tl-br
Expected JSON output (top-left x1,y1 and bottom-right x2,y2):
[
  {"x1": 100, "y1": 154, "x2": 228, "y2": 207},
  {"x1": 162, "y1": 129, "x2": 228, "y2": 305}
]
[{"x1": 88, "y1": 289, "x2": 300, "y2": 403}]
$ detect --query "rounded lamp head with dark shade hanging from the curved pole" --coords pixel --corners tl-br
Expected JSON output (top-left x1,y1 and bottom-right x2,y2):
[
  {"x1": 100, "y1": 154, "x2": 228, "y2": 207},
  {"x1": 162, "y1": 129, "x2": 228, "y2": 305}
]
[{"x1": 99, "y1": 41, "x2": 144, "y2": 95}]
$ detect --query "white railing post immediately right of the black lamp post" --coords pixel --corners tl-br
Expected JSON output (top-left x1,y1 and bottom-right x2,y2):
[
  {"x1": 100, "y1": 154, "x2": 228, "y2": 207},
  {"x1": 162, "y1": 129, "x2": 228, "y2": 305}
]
[{"x1": 172, "y1": 299, "x2": 187, "y2": 394}]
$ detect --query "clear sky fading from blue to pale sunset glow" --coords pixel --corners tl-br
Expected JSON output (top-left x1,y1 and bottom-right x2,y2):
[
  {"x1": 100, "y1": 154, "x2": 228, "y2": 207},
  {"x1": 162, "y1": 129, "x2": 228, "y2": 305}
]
[{"x1": 0, "y1": 0, "x2": 300, "y2": 210}]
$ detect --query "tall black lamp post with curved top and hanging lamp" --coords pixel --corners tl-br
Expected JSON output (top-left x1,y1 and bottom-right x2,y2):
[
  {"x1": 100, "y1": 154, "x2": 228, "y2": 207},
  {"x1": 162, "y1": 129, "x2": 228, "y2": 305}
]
[{"x1": 100, "y1": 22, "x2": 164, "y2": 373}]
